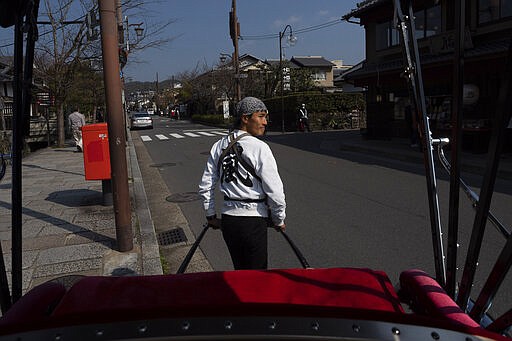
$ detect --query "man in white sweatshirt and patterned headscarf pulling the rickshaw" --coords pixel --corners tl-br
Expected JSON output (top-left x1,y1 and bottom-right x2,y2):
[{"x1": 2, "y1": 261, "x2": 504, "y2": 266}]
[{"x1": 199, "y1": 97, "x2": 286, "y2": 270}]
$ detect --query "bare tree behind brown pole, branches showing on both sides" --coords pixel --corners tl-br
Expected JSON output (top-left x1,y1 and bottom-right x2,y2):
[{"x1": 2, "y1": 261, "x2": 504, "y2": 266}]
[{"x1": 35, "y1": 0, "x2": 174, "y2": 146}]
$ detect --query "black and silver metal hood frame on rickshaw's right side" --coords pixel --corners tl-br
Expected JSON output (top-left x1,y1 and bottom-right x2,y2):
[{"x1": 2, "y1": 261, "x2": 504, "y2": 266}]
[{"x1": 394, "y1": 0, "x2": 512, "y2": 327}]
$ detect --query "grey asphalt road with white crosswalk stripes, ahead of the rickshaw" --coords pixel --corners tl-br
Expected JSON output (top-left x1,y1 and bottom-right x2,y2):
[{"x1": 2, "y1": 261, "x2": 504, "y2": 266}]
[{"x1": 133, "y1": 118, "x2": 512, "y2": 318}]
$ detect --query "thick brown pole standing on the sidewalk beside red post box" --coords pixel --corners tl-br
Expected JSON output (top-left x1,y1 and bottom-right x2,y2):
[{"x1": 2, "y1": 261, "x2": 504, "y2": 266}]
[{"x1": 98, "y1": 0, "x2": 133, "y2": 252}]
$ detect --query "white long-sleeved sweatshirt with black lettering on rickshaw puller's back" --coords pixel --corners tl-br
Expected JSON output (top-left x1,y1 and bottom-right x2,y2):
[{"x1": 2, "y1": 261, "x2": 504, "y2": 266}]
[{"x1": 199, "y1": 130, "x2": 286, "y2": 225}]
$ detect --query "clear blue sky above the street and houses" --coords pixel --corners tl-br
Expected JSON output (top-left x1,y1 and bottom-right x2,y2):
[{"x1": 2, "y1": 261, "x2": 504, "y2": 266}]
[{"x1": 124, "y1": 0, "x2": 365, "y2": 81}]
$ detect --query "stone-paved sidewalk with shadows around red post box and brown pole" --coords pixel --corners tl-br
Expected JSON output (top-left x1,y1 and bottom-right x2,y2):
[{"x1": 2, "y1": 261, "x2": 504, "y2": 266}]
[{"x1": 0, "y1": 133, "x2": 162, "y2": 293}]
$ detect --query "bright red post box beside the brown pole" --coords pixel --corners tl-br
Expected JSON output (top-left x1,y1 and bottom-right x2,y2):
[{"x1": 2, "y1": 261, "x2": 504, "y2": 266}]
[{"x1": 82, "y1": 123, "x2": 110, "y2": 180}]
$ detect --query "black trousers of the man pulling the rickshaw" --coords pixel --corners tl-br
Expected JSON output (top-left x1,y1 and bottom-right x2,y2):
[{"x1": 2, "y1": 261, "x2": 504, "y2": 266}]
[{"x1": 222, "y1": 214, "x2": 268, "y2": 270}]
